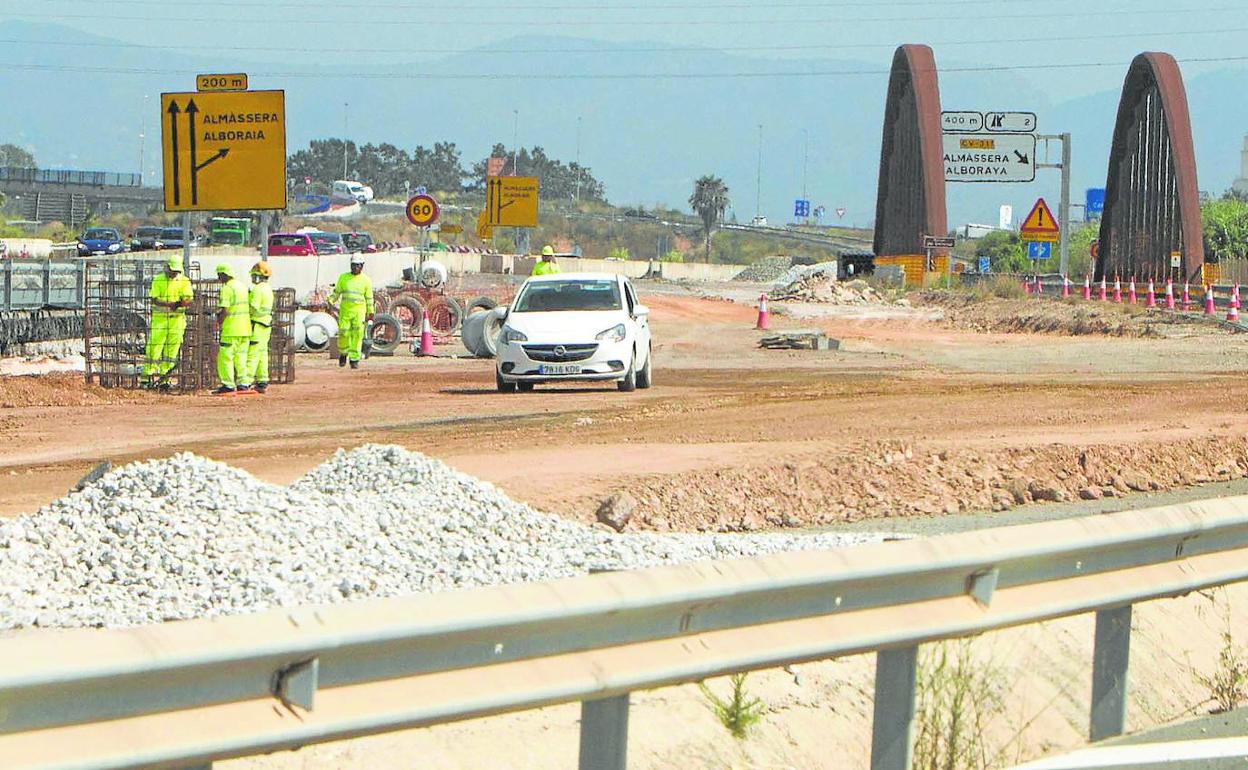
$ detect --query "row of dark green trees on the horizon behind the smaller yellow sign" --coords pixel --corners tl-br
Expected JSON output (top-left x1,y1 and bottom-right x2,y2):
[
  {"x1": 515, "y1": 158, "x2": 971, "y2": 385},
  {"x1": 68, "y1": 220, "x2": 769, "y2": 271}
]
[{"x1": 287, "y1": 139, "x2": 607, "y2": 202}]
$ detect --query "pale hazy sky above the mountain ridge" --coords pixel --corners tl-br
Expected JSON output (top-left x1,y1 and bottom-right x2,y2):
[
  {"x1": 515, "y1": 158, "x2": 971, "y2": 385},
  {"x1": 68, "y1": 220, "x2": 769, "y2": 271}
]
[{"x1": 9, "y1": 0, "x2": 1248, "y2": 101}]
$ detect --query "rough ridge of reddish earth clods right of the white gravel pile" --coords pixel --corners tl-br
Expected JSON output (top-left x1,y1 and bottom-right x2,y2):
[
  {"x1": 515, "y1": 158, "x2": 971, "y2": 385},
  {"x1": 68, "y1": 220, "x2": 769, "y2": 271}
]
[{"x1": 577, "y1": 437, "x2": 1248, "y2": 532}]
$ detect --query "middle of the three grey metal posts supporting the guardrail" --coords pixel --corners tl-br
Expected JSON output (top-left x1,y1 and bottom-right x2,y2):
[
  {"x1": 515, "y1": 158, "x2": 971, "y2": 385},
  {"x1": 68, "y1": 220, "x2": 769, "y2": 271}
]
[{"x1": 871, "y1": 646, "x2": 919, "y2": 770}]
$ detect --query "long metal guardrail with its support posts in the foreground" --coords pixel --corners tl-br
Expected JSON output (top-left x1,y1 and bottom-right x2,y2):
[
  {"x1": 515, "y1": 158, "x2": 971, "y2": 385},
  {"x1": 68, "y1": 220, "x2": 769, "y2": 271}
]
[{"x1": 0, "y1": 497, "x2": 1248, "y2": 770}]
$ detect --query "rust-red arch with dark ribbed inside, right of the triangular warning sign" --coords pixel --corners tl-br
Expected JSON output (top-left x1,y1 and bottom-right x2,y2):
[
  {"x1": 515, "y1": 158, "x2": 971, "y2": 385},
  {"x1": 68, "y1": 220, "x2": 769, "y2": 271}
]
[{"x1": 1096, "y1": 52, "x2": 1204, "y2": 281}]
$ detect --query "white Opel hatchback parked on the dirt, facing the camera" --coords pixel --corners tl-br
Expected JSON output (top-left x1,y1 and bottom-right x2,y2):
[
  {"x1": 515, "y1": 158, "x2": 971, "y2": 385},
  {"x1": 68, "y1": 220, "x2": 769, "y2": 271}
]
[{"x1": 494, "y1": 273, "x2": 651, "y2": 393}]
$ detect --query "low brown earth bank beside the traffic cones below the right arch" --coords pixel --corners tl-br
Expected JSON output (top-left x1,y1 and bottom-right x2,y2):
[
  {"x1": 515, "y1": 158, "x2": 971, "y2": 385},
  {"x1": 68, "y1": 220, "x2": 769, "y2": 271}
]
[{"x1": 915, "y1": 290, "x2": 1219, "y2": 337}]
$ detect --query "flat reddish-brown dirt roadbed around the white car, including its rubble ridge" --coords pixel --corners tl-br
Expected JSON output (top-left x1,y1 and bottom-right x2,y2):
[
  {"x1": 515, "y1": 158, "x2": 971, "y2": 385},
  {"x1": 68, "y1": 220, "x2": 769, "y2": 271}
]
[{"x1": 0, "y1": 285, "x2": 1248, "y2": 530}]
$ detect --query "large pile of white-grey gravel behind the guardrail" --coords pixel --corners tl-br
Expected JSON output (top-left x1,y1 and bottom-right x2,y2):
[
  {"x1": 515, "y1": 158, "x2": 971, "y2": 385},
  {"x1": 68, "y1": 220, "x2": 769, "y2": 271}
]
[{"x1": 0, "y1": 446, "x2": 877, "y2": 629}]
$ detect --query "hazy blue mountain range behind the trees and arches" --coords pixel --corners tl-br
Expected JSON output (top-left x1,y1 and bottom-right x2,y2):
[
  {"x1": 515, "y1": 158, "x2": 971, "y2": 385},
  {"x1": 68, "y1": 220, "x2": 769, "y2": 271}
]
[{"x1": 0, "y1": 20, "x2": 1248, "y2": 227}]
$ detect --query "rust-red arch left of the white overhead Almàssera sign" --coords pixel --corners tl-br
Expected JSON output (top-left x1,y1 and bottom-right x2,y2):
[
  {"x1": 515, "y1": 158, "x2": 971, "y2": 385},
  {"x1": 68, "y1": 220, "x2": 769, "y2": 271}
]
[{"x1": 875, "y1": 45, "x2": 948, "y2": 257}]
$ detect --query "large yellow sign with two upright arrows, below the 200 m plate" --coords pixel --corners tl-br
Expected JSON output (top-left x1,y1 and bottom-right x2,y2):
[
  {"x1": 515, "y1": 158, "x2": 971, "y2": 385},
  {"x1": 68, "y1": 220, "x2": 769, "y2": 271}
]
[{"x1": 161, "y1": 91, "x2": 286, "y2": 211}]
